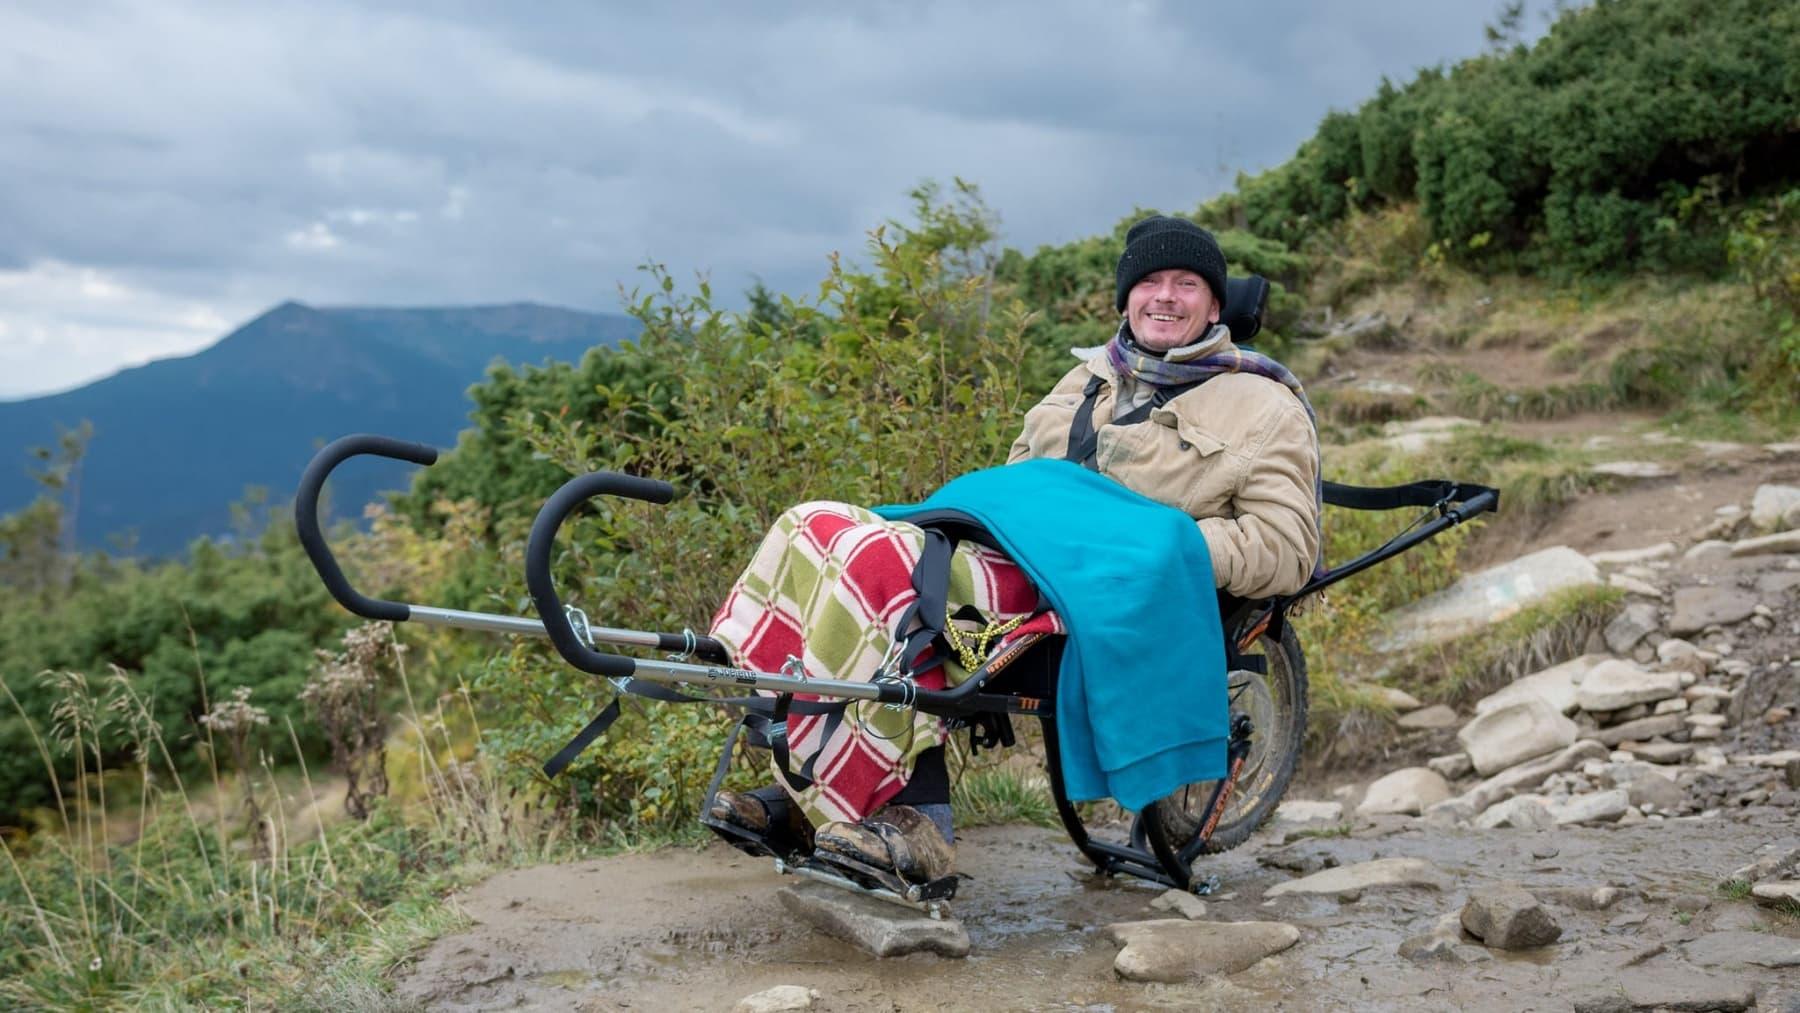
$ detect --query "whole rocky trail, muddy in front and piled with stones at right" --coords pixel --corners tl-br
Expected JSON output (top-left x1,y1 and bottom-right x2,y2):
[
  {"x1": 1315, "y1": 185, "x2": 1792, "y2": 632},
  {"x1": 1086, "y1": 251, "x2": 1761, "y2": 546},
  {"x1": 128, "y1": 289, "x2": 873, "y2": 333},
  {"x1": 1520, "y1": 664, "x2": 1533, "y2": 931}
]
[{"x1": 396, "y1": 428, "x2": 1800, "y2": 1011}]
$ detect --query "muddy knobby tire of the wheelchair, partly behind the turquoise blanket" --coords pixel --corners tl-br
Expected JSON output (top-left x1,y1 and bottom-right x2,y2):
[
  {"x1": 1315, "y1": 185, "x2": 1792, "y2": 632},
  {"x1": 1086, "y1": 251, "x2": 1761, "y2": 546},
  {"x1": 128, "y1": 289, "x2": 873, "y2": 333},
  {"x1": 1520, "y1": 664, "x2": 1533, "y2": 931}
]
[{"x1": 1145, "y1": 624, "x2": 1307, "y2": 855}]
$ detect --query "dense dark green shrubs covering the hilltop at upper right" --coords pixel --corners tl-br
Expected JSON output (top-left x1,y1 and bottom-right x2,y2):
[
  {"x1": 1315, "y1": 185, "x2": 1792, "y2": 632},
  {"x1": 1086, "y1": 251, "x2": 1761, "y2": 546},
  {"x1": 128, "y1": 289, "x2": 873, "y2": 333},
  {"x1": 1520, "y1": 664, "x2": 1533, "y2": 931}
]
[{"x1": 1201, "y1": 0, "x2": 1800, "y2": 272}]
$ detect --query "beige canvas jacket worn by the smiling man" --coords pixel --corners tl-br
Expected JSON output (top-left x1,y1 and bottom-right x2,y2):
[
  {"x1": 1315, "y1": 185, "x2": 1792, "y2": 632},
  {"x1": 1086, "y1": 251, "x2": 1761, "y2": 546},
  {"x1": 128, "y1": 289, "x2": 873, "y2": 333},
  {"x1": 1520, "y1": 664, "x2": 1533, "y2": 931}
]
[{"x1": 1006, "y1": 354, "x2": 1319, "y2": 597}]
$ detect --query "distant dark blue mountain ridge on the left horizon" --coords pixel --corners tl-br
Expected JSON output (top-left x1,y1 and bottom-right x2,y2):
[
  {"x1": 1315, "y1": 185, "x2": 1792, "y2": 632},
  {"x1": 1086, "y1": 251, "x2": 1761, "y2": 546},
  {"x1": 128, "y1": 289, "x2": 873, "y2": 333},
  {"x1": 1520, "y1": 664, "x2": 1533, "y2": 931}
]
[{"x1": 0, "y1": 302, "x2": 639, "y2": 554}]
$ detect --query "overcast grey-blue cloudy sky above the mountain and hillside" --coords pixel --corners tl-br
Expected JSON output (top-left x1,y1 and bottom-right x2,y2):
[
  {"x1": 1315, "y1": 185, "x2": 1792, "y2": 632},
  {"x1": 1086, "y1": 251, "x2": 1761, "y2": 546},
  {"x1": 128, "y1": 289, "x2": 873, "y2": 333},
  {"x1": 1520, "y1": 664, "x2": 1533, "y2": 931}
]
[{"x1": 0, "y1": 0, "x2": 1537, "y2": 398}]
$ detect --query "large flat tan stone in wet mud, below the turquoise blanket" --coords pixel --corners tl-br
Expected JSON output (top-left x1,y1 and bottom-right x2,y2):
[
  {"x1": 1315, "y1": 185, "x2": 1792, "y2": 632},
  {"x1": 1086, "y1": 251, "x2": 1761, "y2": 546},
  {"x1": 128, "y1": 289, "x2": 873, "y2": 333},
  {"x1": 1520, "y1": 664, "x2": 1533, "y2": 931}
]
[{"x1": 1107, "y1": 918, "x2": 1300, "y2": 984}]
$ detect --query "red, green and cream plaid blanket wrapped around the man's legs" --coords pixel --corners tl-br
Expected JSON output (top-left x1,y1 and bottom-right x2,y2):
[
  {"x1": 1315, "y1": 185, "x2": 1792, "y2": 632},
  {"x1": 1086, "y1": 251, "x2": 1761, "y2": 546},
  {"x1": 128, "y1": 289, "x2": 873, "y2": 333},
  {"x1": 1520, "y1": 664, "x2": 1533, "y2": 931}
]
[{"x1": 711, "y1": 502, "x2": 1062, "y2": 826}]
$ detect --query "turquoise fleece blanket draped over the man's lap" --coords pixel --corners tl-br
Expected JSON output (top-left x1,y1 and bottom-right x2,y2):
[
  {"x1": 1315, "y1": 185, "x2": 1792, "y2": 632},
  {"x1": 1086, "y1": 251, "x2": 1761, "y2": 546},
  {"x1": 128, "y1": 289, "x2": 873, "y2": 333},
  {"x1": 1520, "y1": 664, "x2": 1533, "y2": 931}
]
[{"x1": 875, "y1": 461, "x2": 1229, "y2": 810}]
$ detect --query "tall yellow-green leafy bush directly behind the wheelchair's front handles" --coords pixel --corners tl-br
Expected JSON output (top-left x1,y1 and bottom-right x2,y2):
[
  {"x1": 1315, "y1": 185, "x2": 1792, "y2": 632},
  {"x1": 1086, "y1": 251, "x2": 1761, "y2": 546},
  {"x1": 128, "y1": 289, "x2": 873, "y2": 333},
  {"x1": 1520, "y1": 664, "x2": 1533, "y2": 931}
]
[{"x1": 457, "y1": 184, "x2": 1033, "y2": 833}]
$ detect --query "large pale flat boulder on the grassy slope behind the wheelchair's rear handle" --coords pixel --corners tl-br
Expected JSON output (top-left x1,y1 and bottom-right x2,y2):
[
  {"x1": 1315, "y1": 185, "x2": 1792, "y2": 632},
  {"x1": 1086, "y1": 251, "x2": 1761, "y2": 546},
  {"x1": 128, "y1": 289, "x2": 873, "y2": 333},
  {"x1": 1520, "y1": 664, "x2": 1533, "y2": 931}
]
[{"x1": 1375, "y1": 545, "x2": 1600, "y2": 651}]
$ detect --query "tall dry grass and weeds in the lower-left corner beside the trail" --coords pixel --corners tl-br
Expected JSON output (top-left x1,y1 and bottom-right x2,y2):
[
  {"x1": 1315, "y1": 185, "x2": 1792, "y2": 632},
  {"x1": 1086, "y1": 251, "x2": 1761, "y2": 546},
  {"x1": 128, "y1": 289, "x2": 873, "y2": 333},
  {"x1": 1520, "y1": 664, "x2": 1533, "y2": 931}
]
[{"x1": 0, "y1": 658, "x2": 578, "y2": 1009}]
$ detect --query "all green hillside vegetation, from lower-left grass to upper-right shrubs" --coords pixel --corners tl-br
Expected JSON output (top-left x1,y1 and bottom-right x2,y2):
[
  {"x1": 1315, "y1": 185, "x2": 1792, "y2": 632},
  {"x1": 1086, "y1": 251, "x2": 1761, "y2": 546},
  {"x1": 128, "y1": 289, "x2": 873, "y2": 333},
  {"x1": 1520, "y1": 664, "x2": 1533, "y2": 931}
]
[{"x1": 0, "y1": 0, "x2": 1800, "y2": 1006}]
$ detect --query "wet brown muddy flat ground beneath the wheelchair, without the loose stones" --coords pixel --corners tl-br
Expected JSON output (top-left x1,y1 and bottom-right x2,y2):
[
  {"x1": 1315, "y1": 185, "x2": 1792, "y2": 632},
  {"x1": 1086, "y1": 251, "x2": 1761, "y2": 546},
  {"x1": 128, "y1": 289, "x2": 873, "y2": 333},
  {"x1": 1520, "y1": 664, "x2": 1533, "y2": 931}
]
[{"x1": 396, "y1": 808, "x2": 1800, "y2": 1011}]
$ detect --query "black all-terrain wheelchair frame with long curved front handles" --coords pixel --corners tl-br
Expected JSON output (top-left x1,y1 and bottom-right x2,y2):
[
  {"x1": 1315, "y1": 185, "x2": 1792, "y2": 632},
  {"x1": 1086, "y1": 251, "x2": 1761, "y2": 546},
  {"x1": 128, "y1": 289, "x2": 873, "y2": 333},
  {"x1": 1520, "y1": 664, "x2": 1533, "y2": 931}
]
[{"x1": 295, "y1": 275, "x2": 1499, "y2": 914}]
